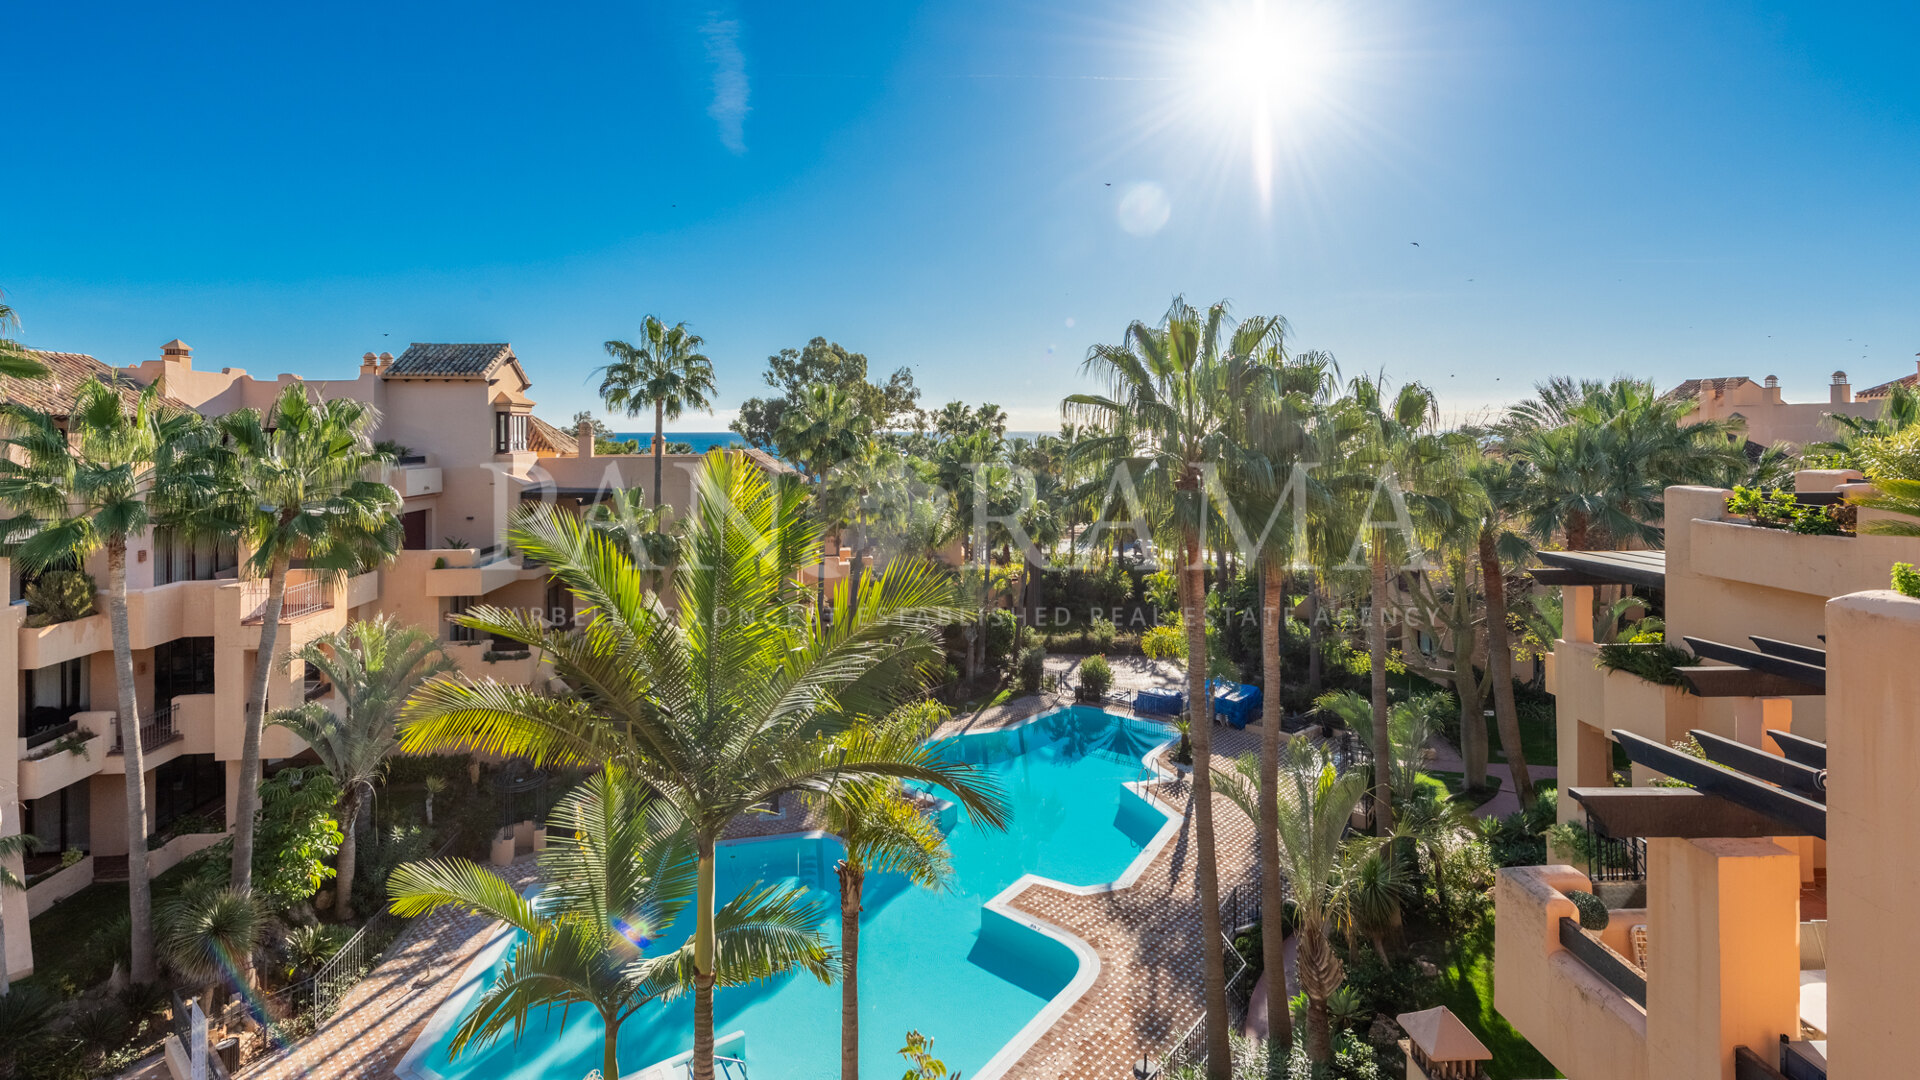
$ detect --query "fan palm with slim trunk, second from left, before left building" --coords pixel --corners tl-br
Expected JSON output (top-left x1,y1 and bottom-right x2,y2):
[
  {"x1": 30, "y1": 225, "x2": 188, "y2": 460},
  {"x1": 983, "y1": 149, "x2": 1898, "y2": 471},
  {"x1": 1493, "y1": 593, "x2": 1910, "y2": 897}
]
[{"x1": 186, "y1": 382, "x2": 401, "y2": 892}]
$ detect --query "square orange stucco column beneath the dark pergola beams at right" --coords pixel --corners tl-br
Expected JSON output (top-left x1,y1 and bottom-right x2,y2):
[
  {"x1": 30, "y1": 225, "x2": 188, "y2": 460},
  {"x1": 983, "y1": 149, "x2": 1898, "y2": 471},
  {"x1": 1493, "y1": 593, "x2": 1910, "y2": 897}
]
[{"x1": 1647, "y1": 838, "x2": 1799, "y2": 1080}]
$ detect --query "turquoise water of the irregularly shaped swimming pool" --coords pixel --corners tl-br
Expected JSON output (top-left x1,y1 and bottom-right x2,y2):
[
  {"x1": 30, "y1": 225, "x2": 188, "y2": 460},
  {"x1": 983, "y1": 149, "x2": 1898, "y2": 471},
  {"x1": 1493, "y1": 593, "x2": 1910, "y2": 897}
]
[{"x1": 409, "y1": 707, "x2": 1167, "y2": 1080}]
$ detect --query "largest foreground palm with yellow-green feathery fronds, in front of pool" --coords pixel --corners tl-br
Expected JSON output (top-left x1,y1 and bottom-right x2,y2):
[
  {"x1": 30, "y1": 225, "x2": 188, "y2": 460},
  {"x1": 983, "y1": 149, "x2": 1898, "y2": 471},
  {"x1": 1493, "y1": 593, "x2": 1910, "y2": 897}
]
[{"x1": 401, "y1": 454, "x2": 1006, "y2": 1080}]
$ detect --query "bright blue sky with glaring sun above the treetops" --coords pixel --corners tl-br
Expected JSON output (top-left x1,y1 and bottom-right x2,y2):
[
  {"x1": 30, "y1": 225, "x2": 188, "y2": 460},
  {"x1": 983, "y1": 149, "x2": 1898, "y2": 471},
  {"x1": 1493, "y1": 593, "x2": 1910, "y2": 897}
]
[{"x1": 0, "y1": 0, "x2": 1920, "y2": 430}]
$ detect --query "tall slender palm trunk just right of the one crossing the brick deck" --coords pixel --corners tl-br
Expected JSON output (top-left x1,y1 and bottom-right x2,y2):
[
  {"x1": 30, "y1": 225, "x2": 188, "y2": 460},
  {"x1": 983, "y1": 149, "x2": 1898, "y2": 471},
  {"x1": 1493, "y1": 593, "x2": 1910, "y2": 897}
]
[{"x1": 1258, "y1": 557, "x2": 1294, "y2": 1060}]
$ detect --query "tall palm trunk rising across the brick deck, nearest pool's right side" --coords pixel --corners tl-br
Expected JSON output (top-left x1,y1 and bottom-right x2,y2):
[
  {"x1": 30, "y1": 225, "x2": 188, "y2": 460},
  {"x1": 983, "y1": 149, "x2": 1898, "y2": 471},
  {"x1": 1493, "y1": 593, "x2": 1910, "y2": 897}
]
[{"x1": 1175, "y1": 527, "x2": 1233, "y2": 1080}]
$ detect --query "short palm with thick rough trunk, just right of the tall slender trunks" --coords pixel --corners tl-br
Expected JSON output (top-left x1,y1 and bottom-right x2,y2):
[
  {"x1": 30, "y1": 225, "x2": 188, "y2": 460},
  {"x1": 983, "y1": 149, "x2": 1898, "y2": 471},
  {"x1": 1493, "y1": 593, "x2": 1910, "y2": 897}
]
[{"x1": 1221, "y1": 738, "x2": 1371, "y2": 1068}]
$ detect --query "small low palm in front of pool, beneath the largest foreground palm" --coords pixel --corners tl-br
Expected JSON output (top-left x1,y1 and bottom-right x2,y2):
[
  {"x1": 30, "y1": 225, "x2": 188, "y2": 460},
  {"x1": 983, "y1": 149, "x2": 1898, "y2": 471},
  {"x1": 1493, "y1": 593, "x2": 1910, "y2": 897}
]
[{"x1": 388, "y1": 769, "x2": 835, "y2": 1078}]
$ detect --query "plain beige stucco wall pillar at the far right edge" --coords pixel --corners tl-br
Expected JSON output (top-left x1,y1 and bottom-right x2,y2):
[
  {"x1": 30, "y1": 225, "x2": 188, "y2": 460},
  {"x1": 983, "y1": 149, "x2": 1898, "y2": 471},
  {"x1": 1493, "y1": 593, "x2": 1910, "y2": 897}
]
[{"x1": 1826, "y1": 590, "x2": 1920, "y2": 1076}]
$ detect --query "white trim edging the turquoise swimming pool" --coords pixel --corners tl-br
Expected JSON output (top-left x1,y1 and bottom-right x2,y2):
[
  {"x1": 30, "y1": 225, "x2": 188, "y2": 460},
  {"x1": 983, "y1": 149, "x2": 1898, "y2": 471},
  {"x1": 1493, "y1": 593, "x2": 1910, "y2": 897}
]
[{"x1": 394, "y1": 701, "x2": 1181, "y2": 1080}]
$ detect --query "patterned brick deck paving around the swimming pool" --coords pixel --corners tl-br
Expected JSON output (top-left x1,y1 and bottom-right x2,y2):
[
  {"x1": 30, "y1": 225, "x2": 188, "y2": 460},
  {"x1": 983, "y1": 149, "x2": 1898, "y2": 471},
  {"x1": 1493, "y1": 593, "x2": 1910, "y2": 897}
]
[{"x1": 242, "y1": 698, "x2": 1260, "y2": 1080}]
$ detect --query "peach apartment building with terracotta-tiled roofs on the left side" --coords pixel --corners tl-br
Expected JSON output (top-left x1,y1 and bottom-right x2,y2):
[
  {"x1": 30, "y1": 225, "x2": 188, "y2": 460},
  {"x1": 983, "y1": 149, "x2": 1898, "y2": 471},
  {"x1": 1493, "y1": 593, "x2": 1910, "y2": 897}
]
[{"x1": 0, "y1": 340, "x2": 785, "y2": 976}]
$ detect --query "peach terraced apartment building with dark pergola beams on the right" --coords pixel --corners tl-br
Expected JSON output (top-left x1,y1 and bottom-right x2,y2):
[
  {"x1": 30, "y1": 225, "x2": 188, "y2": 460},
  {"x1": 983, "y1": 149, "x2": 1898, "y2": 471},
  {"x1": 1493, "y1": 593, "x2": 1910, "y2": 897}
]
[{"x1": 1494, "y1": 471, "x2": 1920, "y2": 1080}]
